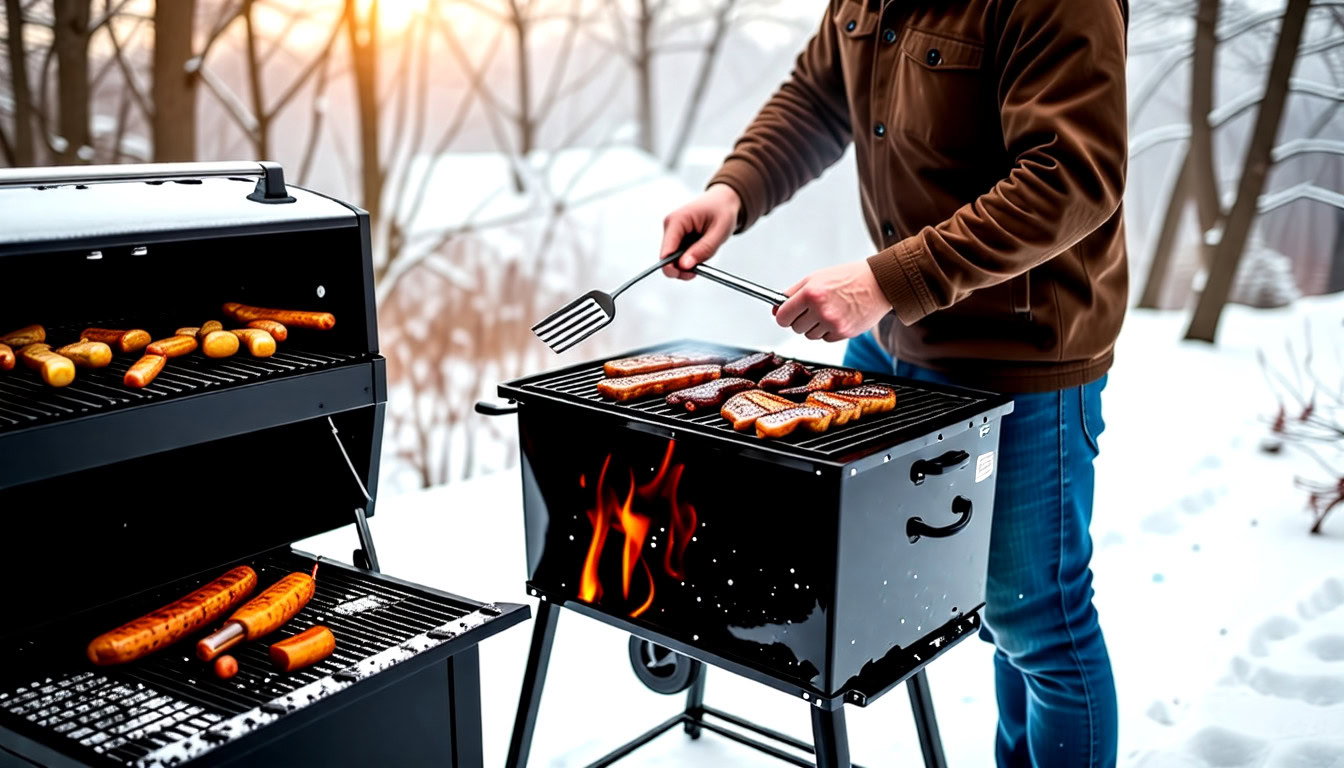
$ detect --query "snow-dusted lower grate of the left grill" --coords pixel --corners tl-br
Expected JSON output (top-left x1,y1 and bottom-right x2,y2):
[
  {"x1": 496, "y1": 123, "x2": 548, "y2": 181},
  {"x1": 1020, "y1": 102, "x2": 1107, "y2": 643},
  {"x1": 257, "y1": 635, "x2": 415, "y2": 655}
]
[{"x1": 0, "y1": 553, "x2": 489, "y2": 764}]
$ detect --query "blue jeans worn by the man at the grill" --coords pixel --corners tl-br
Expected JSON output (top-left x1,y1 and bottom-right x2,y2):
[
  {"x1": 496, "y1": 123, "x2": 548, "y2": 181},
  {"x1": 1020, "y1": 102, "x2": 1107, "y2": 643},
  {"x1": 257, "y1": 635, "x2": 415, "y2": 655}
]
[{"x1": 844, "y1": 334, "x2": 1118, "y2": 768}]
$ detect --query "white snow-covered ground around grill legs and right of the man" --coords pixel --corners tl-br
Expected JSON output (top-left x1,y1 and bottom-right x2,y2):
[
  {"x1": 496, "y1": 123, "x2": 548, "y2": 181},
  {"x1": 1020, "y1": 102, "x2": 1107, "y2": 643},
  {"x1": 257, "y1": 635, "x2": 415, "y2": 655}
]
[{"x1": 306, "y1": 297, "x2": 1344, "y2": 768}]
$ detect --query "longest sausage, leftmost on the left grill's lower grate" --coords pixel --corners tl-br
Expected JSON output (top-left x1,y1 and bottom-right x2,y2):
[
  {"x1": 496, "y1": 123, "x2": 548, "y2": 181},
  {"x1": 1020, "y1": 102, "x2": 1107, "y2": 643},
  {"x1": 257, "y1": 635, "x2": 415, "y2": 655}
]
[{"x1": 89, "y1": 565, "x2": 257, "y2": 666}]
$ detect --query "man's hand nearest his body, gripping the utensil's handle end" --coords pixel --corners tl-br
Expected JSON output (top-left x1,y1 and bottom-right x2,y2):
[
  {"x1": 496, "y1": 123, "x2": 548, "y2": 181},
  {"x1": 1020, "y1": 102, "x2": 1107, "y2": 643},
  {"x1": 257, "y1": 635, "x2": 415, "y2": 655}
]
[{"x1": 774, "y1": 261, "x2": 891, "y2": 342}]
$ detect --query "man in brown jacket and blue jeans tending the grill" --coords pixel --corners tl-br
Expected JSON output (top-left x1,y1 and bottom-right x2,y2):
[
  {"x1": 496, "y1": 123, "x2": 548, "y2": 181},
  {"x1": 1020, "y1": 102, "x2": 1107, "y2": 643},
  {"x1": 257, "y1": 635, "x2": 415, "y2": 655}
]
[{"x1": 663, "y1": 0, "x2": 1129, "y2": 767}]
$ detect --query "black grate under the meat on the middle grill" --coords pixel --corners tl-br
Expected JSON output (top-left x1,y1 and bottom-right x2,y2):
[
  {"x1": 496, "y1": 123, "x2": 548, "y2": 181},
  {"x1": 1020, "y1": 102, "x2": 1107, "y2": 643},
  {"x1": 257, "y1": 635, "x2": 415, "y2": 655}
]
[{"x1": 500, "y1": 344, "x2": 999, "y2": 460}]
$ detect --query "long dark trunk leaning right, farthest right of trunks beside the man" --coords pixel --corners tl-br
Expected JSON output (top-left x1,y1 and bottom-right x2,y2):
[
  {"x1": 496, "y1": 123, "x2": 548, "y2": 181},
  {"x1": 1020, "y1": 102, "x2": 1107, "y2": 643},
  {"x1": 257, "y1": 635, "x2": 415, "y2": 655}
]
[{"x1": 1185, "y1": 0, "x2": 1312, "y2": 342}]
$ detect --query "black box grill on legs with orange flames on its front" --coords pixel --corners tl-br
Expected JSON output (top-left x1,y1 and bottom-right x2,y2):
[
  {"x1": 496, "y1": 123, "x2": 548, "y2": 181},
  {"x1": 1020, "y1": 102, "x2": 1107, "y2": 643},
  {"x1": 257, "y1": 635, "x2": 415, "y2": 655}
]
[{"x1": 480, "y1": 342, "x2": 1012, "y2": 768}]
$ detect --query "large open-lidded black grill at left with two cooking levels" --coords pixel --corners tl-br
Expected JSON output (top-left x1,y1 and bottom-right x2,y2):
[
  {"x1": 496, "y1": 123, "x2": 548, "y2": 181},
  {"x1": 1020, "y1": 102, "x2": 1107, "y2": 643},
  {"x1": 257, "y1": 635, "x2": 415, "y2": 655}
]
[{"x1": 0, "y1": 163, "x2": 528, "y2": 768}]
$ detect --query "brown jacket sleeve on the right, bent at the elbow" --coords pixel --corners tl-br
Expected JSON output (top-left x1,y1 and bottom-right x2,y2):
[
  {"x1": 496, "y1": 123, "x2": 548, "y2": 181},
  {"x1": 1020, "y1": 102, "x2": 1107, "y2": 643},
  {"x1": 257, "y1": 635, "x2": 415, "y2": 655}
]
[{"x1": 868, "y1": 0, "x2": 1129, "y2": 325}]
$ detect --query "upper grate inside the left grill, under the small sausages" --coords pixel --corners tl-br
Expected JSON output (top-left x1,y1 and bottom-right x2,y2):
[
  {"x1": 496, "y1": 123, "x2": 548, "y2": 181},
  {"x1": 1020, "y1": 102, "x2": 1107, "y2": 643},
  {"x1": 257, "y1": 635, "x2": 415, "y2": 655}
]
[{"x1": 0, "y1": 346, "x2": 368, "y2": 434}]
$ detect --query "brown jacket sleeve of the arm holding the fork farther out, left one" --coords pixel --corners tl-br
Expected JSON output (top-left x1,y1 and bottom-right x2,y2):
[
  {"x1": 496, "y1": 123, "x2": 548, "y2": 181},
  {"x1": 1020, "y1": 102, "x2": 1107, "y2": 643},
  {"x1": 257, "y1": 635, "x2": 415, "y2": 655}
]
[{"x1": 710, "y1": 5, "x2": 852, "y2": 233}]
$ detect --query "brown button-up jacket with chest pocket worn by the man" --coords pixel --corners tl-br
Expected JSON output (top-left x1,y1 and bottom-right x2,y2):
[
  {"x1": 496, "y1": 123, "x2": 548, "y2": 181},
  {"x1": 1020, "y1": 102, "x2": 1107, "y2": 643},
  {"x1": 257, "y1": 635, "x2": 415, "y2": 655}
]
[{"x1": 711, "y1": 0, "x2": 1129, "y2": 393}]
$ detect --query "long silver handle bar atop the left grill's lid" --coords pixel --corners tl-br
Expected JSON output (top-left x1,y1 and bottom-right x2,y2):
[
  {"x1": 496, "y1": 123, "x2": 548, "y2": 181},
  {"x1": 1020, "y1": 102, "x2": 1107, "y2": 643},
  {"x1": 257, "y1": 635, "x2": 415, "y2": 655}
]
[{"x1": 0, "y1": 160, "x2": 294, "y2": 203}]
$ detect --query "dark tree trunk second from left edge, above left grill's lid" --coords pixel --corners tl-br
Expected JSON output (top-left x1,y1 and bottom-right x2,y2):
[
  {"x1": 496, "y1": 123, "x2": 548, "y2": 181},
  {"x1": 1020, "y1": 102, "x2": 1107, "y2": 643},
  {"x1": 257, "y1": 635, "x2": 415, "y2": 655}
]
[{"x1": 51, "y1": 0, "x2": 93, "y2": 164}]
